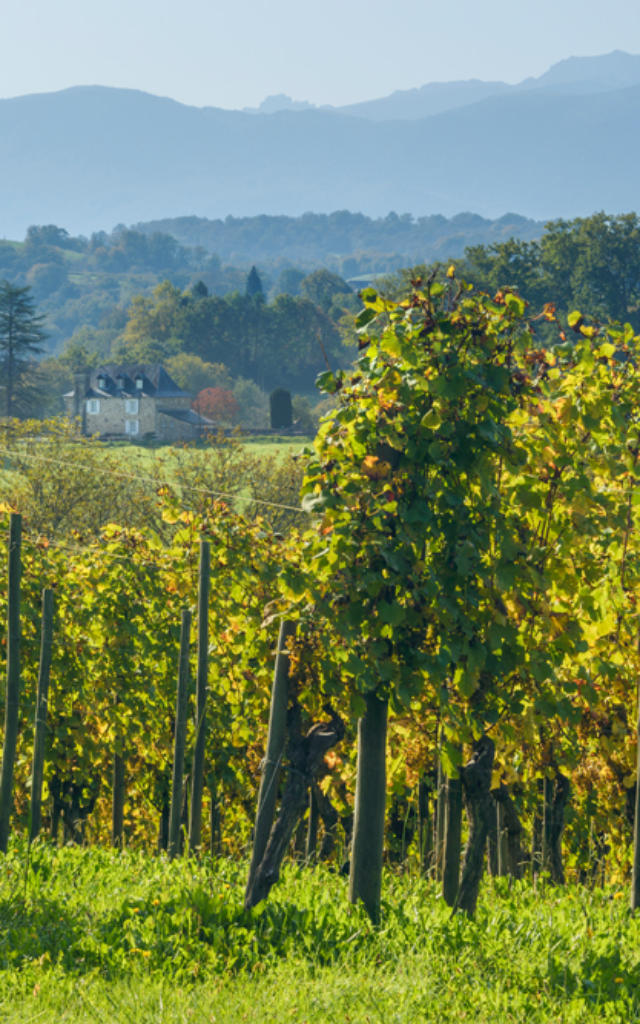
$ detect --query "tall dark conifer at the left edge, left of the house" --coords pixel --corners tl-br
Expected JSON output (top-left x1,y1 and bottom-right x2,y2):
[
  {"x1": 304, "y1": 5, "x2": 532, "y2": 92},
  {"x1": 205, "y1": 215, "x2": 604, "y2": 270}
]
[{"x1": 0, "y1": 281, "x2": 45, "y2": 417}]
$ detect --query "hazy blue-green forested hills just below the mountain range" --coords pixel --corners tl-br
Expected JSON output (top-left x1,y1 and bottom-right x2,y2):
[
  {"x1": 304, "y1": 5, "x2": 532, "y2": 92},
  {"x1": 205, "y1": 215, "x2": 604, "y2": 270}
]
[{"x1": 0, "y1": 211, "x2": 542, "y2": 360}]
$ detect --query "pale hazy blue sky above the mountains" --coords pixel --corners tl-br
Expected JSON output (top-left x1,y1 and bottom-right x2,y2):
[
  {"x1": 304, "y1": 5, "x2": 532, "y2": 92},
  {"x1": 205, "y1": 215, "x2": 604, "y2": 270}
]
[{"x1": 0, "y1": 0, "x2": 640, "y2": 108}]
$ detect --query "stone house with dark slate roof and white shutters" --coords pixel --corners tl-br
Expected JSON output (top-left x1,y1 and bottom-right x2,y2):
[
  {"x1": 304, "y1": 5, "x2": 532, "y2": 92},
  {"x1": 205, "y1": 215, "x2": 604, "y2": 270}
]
[{"x1": 63, "y1": 362, "x2": 214, "y2": 443}]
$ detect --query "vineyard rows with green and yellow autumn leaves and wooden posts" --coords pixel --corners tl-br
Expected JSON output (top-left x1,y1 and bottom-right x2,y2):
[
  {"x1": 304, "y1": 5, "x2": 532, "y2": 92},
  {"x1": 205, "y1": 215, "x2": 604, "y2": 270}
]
[{"x1": 0, "y1": 276, "x2": 640, "y2": 1020}]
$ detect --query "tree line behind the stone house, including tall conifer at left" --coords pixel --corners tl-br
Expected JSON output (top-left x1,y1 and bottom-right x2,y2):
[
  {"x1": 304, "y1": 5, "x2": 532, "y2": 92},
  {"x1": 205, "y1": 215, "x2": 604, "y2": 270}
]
[{"x1": 0, "y1": 267, "x2": 356, "y2": 428}]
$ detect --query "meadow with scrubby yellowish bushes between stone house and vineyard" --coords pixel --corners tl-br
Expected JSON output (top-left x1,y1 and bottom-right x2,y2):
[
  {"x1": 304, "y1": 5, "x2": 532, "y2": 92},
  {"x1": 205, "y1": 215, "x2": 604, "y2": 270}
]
[{"x1": 0, "y1": 435, "x2": 310, "y2": 537}]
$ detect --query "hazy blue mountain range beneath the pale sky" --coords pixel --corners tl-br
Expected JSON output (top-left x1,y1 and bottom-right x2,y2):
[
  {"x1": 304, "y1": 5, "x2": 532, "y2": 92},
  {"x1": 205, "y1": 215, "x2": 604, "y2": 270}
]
[{"x1": 0, "y1": 51, "x2": 640, "y2": 239}]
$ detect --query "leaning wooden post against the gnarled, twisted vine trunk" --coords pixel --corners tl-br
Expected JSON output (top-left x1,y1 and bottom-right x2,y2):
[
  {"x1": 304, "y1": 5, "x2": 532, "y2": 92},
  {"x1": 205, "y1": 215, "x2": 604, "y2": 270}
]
[{"x1": 245, "y1": 620, "x2": 296, "y2": 899}]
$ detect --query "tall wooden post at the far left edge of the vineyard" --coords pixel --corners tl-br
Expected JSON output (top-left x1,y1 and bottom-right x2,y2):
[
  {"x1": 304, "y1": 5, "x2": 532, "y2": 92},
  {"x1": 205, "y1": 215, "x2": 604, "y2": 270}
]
[{"x1": 0, "y1": 512, "x2": 23, "y2": 853}]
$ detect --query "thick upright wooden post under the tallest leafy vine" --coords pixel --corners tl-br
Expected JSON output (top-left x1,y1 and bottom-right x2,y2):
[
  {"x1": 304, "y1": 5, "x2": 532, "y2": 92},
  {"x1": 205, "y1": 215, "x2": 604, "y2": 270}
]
[{"x1": 349, "y1": 693, "x2": 388, "y2": 925}]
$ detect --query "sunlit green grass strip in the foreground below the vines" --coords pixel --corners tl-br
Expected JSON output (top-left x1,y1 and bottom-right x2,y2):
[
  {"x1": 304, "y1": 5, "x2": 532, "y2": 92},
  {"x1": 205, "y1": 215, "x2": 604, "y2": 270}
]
[{"x1": 0, "y1": 844, "x2": 640, "y2": 1024}]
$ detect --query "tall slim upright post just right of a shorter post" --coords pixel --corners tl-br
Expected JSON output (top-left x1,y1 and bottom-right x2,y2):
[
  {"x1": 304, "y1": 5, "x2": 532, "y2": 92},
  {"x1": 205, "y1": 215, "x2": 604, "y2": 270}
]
[{"x1": 188, "y1": 541, "x2": 211, "y2": 853}]
